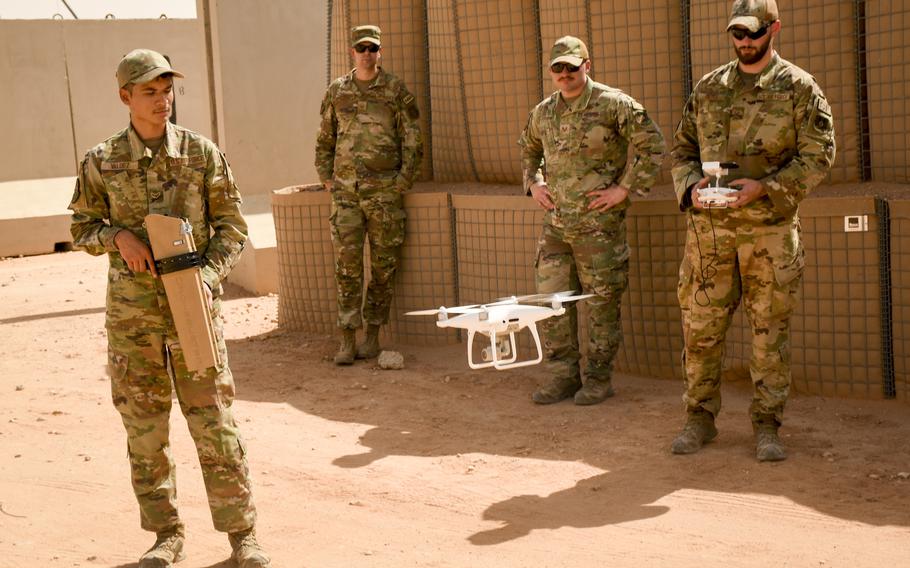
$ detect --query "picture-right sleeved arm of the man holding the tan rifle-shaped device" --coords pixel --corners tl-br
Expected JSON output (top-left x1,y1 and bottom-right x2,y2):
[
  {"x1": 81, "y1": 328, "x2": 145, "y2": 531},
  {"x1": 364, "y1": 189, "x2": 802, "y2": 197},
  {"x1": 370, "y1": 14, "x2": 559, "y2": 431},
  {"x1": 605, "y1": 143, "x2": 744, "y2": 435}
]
[{"x1": 202, "y1": 146, "x2": 247, "y2": 290}]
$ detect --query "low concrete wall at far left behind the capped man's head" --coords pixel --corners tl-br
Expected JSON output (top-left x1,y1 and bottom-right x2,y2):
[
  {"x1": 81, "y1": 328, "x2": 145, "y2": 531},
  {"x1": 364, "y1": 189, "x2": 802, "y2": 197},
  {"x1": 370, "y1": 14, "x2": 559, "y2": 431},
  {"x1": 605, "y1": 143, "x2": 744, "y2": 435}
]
[{"x1": 0, "y1": 20, "x2": 211, "y2": 181}]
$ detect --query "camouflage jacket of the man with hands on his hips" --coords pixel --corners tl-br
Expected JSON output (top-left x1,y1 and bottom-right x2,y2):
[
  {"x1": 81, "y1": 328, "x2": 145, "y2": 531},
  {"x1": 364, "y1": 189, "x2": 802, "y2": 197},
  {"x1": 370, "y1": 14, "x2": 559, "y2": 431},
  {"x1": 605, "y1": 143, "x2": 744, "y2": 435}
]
[{"x1": 518, "y1": 77, "x2": 664, "y2": 232}]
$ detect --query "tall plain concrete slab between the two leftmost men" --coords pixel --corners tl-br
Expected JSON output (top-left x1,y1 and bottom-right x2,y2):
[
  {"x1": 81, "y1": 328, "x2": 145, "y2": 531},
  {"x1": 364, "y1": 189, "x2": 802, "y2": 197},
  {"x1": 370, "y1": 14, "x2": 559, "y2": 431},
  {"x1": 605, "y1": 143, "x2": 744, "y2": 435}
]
[{"x1": 209, "y1": 0, "x2": 328, "y2": 200}]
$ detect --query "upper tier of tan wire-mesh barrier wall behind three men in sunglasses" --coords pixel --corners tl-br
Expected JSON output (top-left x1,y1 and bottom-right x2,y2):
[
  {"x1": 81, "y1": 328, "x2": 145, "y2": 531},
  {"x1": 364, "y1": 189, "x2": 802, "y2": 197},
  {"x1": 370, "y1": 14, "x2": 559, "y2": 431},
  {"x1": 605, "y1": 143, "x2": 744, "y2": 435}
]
[{"x1": 328, "y1": 0, "x2": 910, "y2": 187}]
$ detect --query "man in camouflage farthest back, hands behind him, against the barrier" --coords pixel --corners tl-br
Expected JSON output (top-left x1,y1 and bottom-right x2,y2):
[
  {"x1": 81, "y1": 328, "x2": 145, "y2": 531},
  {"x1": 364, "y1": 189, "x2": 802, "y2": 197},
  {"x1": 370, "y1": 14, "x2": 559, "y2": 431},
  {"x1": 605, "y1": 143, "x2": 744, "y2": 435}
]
[{"x1": 316, "y1": 26, "x2": 423, "y2": 365}]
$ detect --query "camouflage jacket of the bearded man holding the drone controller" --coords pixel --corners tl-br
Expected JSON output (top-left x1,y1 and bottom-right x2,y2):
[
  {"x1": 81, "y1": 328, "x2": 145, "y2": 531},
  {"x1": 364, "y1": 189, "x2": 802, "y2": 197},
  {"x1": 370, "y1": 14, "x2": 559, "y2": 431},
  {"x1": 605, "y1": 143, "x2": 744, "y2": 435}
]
[{"x1": 672, "y1": 53, "x2": 834, "y2": 220}]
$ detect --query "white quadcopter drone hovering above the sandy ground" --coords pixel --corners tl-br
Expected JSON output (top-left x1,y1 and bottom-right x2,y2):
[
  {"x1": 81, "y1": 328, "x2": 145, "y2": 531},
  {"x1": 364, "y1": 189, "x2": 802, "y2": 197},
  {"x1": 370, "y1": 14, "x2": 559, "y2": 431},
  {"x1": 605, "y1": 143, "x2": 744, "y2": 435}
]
[{"x1": 405, "y1": 290, "x2": 592, "y2": 370}]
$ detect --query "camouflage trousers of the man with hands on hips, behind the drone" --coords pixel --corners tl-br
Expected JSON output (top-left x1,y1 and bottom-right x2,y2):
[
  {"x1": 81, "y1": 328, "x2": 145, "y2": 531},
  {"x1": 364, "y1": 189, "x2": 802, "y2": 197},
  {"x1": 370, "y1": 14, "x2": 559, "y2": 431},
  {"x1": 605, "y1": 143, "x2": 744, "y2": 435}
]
[{"x1": 536, "y1": 215, "x2": 629, "y2": 379}]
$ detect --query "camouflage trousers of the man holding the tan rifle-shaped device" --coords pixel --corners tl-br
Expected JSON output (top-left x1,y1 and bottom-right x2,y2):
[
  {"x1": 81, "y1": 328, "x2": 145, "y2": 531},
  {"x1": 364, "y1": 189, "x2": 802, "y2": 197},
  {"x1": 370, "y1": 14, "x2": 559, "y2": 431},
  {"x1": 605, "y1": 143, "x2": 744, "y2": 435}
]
[{"x1": 108, "y1": 300, "x2": 256, "y2": 532}]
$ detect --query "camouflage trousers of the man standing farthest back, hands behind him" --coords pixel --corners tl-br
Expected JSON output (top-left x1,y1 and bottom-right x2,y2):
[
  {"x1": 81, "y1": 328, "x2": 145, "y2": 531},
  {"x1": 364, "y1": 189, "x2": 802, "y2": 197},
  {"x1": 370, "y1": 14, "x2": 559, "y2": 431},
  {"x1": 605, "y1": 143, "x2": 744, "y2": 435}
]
[{"x1": 329, "y1": 182, "x2": 406, "y2": 329}]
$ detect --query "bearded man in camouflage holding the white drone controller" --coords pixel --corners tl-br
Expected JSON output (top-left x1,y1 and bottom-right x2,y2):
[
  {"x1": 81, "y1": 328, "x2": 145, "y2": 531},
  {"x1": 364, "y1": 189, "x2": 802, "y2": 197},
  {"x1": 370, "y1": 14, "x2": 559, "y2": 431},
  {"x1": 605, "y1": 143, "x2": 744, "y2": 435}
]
[{"x1": 671, "y1": 0, "x2": 834, "y2": 461}]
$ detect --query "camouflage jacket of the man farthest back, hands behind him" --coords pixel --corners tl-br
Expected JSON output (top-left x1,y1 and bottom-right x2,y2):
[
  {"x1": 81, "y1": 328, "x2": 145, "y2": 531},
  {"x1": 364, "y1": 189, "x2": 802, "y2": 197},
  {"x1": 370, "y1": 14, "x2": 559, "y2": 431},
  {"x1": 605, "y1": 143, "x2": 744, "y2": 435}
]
[{"x1": 316, "y1": 69, "x2": 423, "y2": 190}]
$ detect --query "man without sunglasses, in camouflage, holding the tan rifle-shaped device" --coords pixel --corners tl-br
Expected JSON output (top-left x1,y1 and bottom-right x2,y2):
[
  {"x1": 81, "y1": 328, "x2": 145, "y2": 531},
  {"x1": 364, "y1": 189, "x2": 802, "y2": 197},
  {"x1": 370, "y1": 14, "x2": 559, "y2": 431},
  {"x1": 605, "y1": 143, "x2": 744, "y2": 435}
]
[{"x1": 69, "y1": 49, "x2": 269, "y2": 568}]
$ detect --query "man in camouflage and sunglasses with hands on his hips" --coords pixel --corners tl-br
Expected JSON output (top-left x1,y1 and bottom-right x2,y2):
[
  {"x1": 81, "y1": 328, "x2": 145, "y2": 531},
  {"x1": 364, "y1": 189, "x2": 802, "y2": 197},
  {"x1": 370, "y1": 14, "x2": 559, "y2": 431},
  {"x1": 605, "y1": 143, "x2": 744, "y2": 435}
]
[{"x1": 519, "y1": 36, "x2": 664, "y2": 405}]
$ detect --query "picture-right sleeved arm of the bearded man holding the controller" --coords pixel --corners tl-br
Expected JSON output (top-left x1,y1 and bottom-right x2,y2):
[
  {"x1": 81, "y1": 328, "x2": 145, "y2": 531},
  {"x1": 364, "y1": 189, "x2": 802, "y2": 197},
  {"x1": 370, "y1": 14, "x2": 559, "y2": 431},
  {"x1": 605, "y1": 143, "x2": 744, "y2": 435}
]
[{"x1": 761, "y1": 81, "x2": 835, "y2": 215}]
